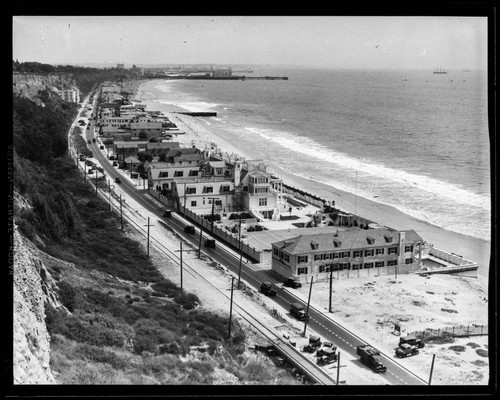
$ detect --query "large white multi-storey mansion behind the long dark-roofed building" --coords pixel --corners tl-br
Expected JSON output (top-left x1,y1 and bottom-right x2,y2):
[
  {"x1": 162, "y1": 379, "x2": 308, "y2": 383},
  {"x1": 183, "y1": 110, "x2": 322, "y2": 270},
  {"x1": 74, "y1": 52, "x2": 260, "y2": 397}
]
[{"x1": 145, "y1": 148, "x2": 282, "y2": 219}]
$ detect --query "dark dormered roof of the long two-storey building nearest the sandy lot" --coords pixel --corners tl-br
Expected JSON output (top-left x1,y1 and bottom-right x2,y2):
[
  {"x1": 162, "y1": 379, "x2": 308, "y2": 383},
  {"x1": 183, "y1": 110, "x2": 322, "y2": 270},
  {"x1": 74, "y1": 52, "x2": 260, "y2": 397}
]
[{"x1": 272, "y1": 227, "x2": 423, "y2": 254}]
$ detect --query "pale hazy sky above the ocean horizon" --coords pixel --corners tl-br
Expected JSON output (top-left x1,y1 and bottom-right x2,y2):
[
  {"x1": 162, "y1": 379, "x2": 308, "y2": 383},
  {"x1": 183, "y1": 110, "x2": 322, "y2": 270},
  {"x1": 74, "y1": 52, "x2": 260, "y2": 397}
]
[{"x1": 12, "y1": 15, "x2": 487, "y2": 70}]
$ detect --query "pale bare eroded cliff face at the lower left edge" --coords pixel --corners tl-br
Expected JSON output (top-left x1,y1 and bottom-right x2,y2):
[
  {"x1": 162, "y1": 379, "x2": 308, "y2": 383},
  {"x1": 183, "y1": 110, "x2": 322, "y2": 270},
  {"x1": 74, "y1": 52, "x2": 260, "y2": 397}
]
[{"x1": 13, "y1": 225, "x2": 61, "y2": 384}]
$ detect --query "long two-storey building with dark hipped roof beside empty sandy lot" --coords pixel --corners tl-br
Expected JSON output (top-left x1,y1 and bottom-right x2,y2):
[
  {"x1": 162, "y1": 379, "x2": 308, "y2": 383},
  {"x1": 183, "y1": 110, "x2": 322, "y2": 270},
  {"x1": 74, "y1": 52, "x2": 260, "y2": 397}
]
[{"x1": 272, "y1": 227, "x2": 424, "y2": 282}]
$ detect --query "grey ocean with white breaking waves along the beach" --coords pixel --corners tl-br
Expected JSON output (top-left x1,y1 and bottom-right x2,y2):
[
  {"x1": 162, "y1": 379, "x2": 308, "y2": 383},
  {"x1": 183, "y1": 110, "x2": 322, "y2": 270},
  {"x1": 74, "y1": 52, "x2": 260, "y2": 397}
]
[{"x1": 140, "y1": 67, "x2": 491, "y2": 240}]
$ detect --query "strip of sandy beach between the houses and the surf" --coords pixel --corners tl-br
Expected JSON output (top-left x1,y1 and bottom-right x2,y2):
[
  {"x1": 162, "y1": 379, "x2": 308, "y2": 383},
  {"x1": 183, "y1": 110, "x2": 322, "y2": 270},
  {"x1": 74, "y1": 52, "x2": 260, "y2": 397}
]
[{"x1": 133, "y1": 80, "x2": 491, "y2": 285}]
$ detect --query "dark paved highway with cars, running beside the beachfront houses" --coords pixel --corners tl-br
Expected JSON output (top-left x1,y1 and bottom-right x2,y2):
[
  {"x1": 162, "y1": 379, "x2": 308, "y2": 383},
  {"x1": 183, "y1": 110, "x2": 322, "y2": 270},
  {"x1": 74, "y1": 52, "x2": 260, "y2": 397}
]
[{"x1": 81, "y1": 94, "x2": 426, "y2": 385}]
